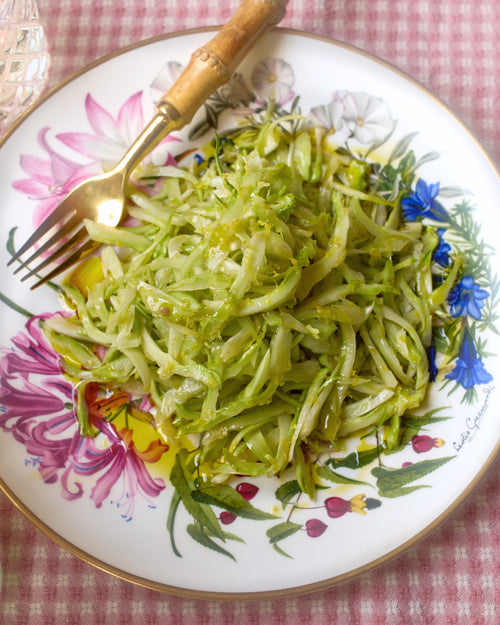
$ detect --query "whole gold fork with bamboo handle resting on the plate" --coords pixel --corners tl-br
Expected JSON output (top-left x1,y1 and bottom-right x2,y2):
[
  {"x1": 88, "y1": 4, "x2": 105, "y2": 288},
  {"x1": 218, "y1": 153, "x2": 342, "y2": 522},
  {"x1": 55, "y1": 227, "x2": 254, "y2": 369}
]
[{"x1": 7, "y1": 0, "x2": 288, "y2": 290}]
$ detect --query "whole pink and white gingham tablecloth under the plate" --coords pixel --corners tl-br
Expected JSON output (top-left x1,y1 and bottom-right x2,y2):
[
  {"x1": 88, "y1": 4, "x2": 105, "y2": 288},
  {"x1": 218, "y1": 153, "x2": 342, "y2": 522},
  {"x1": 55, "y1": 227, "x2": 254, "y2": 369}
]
[{"x1": 0, "y1": 0, "x2": 500, "y2": 625}]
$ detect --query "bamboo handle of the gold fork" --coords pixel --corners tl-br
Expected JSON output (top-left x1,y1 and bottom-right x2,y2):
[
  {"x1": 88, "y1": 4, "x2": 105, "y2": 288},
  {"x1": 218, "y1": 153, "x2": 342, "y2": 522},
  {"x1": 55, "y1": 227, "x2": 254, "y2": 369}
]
[{"x1": 157, "y1": 0, "x2": 288, "y2": 124}]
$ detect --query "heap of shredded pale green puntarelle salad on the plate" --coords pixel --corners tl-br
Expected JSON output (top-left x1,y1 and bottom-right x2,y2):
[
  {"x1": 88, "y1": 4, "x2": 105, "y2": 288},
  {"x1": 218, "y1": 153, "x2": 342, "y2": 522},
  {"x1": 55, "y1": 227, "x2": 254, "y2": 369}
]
[{"x1": 44, "y1": 115, "x2": 458, "y2": 496}]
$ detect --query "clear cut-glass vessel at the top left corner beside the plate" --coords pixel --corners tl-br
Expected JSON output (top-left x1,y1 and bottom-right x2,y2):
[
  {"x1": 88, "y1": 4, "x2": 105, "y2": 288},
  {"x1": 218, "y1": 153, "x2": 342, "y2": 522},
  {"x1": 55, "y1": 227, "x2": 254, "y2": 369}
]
[{"x1": 0, "y1": 0, "x2": 50, "y2": 134}]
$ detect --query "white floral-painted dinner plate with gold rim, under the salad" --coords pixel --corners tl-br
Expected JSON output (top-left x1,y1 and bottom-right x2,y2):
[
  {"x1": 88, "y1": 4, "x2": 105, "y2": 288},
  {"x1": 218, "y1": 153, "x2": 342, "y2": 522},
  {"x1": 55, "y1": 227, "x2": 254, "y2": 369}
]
[{"x1": 0, "y1": 29, "x2": 500, "y2": 598}]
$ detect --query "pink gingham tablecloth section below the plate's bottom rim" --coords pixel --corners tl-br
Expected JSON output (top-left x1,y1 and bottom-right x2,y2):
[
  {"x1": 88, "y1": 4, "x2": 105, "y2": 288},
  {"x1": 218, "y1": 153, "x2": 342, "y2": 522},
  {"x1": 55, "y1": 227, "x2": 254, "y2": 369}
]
[{"x1": 0, "y1": 462, "x2": 500, "y2": 625}]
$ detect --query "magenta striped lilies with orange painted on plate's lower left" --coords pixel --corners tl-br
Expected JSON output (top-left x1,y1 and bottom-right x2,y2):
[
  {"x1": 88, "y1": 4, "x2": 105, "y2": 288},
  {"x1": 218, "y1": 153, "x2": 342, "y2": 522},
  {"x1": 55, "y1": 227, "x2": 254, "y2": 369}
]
[{"x1": 0, "y1": 316, "x2": 168, "y2": 520}]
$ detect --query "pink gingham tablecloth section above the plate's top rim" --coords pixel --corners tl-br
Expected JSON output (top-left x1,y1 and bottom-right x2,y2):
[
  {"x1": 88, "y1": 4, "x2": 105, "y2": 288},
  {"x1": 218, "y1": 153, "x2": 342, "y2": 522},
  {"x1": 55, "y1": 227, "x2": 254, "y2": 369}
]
[{"x1": 38, "y1": 0, "x2": 500, "y2": 168}]
